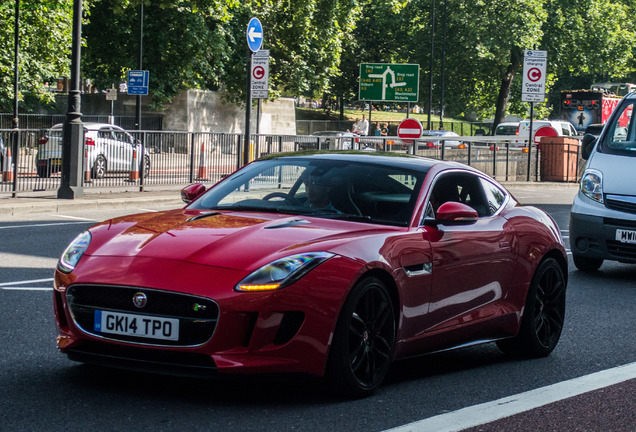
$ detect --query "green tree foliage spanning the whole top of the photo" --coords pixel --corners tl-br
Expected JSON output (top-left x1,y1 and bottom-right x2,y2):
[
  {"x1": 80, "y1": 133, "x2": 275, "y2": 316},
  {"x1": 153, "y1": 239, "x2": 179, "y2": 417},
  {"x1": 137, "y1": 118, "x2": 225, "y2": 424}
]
[{"x1": 0, "y1": 0, "x2": 636, "y2": 119}]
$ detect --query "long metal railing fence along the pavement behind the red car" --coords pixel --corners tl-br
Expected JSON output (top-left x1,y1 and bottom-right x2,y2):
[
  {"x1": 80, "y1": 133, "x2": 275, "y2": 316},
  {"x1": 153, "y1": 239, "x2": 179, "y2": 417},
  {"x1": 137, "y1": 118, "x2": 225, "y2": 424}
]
[{"x1": 0, "y1": 129, "x2": 583, "y2": 197}]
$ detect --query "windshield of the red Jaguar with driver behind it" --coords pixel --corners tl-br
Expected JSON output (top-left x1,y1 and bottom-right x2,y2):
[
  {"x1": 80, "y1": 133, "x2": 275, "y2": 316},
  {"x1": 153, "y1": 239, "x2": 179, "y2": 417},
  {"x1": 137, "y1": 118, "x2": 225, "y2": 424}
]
[{"x1": 189, "y1": 157, "x2": 426, "y2": 226}]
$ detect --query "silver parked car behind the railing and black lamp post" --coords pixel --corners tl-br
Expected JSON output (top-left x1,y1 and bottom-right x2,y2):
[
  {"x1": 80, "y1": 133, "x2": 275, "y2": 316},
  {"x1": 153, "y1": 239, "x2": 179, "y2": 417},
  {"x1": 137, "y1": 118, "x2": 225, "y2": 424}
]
[{"x1": 36, "y1": 123, "x2": 150, "y2": 179}]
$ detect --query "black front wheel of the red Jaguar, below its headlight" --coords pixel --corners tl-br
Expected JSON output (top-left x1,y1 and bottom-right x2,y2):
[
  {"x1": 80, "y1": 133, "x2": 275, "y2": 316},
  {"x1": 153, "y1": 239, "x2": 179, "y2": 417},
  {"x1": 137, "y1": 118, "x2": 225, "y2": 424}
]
[{"x1": 327, "y1": 278, "x2": 396, "y2": 397}]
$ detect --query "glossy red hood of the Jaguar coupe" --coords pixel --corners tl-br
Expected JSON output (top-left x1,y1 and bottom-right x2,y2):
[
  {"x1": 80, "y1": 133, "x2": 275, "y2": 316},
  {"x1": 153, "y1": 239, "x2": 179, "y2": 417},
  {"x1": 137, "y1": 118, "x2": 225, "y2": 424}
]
[{"x1": 86, "y1": 209, "x2": 394, "y2": 270}]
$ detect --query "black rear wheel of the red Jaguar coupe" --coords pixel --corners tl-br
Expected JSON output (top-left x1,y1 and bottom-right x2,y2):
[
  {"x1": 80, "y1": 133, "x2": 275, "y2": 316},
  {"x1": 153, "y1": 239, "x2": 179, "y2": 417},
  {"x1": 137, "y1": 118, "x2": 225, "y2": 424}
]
[{"x1": 497, "y1": 258, "x2": 566, "y2": 358}]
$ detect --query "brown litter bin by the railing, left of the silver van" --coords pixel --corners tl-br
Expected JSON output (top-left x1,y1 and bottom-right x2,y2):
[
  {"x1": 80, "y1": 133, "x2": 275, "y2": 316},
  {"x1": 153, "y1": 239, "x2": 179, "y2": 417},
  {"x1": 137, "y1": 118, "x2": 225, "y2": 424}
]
[{"x1": 539, "y1": 136, "x2": 580, "y2": 182}]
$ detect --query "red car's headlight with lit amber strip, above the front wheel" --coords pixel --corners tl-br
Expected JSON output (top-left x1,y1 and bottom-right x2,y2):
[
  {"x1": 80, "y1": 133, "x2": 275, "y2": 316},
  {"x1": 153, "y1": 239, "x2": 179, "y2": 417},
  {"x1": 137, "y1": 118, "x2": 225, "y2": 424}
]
[{"x1": 235, "y1": 252, "x2": 334, "y2": 292}]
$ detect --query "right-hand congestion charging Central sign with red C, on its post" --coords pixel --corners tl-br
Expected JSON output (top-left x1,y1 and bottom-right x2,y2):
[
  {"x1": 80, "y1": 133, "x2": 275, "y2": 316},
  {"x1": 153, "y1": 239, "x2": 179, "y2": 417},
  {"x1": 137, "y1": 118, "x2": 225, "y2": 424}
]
[{"x1": 521, "y1": 50, "x2": 548, "y2": 181}]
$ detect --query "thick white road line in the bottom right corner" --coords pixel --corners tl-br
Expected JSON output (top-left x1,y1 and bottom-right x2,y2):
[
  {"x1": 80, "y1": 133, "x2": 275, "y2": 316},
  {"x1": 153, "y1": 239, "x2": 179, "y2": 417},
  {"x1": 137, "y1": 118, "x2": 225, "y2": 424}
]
[{"x1": 385, "y1": 363, "x2": 636, "y2": 432}]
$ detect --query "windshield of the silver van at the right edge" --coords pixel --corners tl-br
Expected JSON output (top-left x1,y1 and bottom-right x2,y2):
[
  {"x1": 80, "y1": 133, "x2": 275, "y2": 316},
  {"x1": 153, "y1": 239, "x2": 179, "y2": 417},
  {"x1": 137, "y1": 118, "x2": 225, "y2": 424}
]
[{"x1": 601, "y1": 102, "x2": 636, "y2": 156}]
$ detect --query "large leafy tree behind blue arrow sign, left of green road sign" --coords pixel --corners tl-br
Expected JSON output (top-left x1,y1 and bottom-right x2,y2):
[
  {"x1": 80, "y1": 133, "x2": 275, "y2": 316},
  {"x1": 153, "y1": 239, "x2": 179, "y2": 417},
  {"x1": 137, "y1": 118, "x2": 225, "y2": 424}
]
[{"x1": 84, "y1": 0, "x2": 355, "y2": 107}]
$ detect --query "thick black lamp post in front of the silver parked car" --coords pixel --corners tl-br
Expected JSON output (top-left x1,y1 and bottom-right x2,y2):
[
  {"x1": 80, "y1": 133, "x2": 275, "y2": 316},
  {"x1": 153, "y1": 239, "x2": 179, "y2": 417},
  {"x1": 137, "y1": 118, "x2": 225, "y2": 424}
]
[{"x1": 57, "y1": 0, "x2": 84, "y2": 199}]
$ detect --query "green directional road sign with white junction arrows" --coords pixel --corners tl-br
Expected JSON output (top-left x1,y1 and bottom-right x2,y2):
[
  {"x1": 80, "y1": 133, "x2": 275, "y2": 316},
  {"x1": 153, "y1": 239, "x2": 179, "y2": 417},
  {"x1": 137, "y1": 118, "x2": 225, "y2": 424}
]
[{"x1": 359, "y1": 63, "x2": 420, "y2": 102}]
